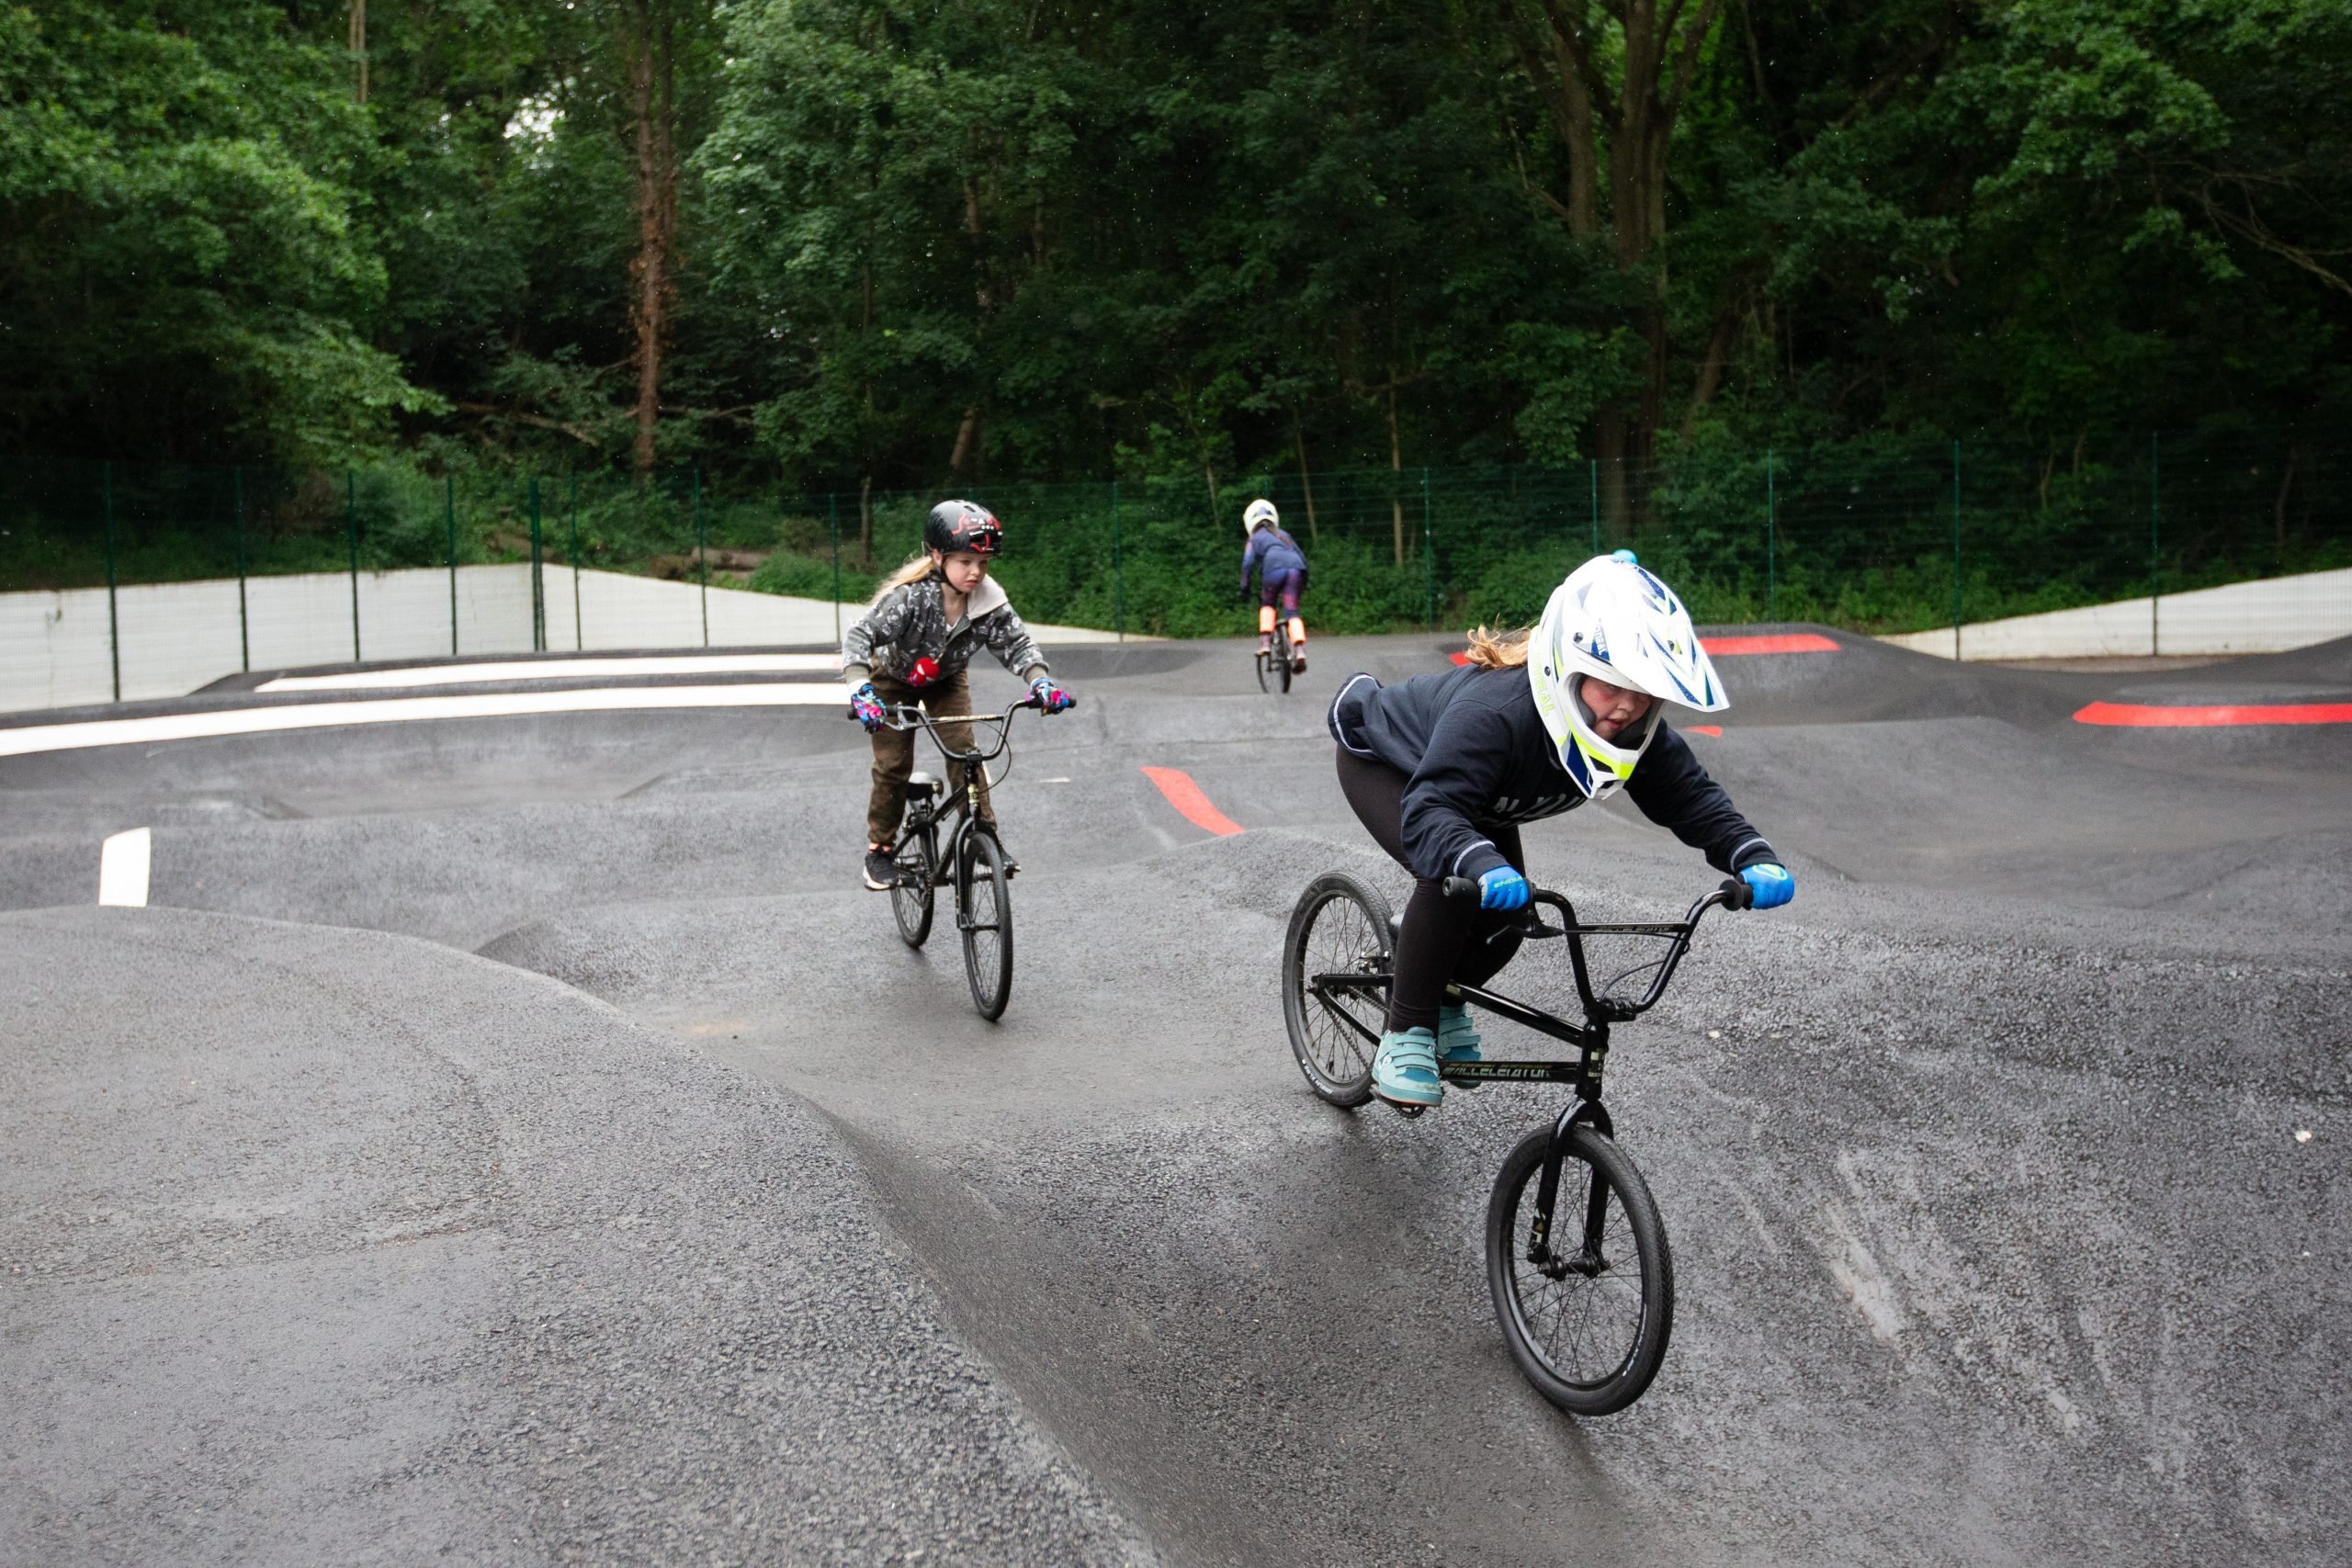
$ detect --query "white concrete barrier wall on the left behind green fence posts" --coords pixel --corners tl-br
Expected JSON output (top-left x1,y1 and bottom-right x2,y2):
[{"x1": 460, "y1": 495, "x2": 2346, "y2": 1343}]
[{"x1": 0, "y1": 564, "x2": 1113, "y2": 712}]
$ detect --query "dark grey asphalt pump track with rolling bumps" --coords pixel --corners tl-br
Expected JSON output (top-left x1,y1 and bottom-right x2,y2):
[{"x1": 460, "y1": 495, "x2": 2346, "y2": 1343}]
[{"x1": 0, "y1": 627, "x2": 2352, "y2": 1565}]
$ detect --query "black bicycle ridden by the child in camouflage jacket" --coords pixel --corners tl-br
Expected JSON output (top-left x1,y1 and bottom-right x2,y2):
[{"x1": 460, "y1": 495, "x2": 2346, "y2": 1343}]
[{"x1": 882, "y1": 696, "x2": 1045, "y2": 1018}]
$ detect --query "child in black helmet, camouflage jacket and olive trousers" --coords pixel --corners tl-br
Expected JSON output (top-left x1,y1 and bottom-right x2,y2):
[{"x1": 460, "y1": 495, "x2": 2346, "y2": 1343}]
[{"x1": 842, "y1": 501, "x2": 1070, "y2": 894}]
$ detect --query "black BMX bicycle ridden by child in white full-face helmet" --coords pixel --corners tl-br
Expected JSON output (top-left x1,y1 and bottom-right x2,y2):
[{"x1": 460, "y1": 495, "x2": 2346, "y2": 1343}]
[{"x1": 1282, "y1": 872, "x2": 1755, "y2": 1416}]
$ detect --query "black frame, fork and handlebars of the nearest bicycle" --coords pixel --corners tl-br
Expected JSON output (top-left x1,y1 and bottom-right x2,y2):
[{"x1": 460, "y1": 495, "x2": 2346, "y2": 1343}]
[{"x1": 1307, "y1": 879, "x2": 1750, "y2": 1269}]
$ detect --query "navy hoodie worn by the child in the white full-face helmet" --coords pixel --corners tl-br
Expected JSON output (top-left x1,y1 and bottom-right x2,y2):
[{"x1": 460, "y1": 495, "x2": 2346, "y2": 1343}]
[{"x1": 1329, "y1": 665, "x2": 1778, "y2": 879}]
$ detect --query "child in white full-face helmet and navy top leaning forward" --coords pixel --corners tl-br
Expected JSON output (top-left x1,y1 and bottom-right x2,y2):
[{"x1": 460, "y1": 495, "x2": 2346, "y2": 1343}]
[{"x1": 1329, "y1": 550, "x2": 1797, "y2": 1107}]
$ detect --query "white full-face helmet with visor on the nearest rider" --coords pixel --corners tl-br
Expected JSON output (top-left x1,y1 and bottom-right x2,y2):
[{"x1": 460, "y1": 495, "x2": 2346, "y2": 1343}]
[{"x1": 1526, "y1": 550, "x2": 1731, "y2": 799}]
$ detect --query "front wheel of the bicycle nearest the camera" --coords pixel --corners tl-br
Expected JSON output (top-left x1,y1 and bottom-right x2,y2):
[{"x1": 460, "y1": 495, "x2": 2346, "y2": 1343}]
[{"x1": 1487, "y1": 1126, "x2": 1675, "y2": 1416}]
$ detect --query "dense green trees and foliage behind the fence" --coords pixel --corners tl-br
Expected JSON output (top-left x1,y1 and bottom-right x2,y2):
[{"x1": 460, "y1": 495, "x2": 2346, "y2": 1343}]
[{"x1": 0, "y1": 0, "x2": 2352, "y2": 545}]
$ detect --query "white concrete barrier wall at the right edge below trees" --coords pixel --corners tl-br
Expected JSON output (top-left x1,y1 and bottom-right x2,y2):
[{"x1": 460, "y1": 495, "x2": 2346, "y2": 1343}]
[{"x1": 1884, "y1": 571, "x2": 2352, "y2": 660}]
